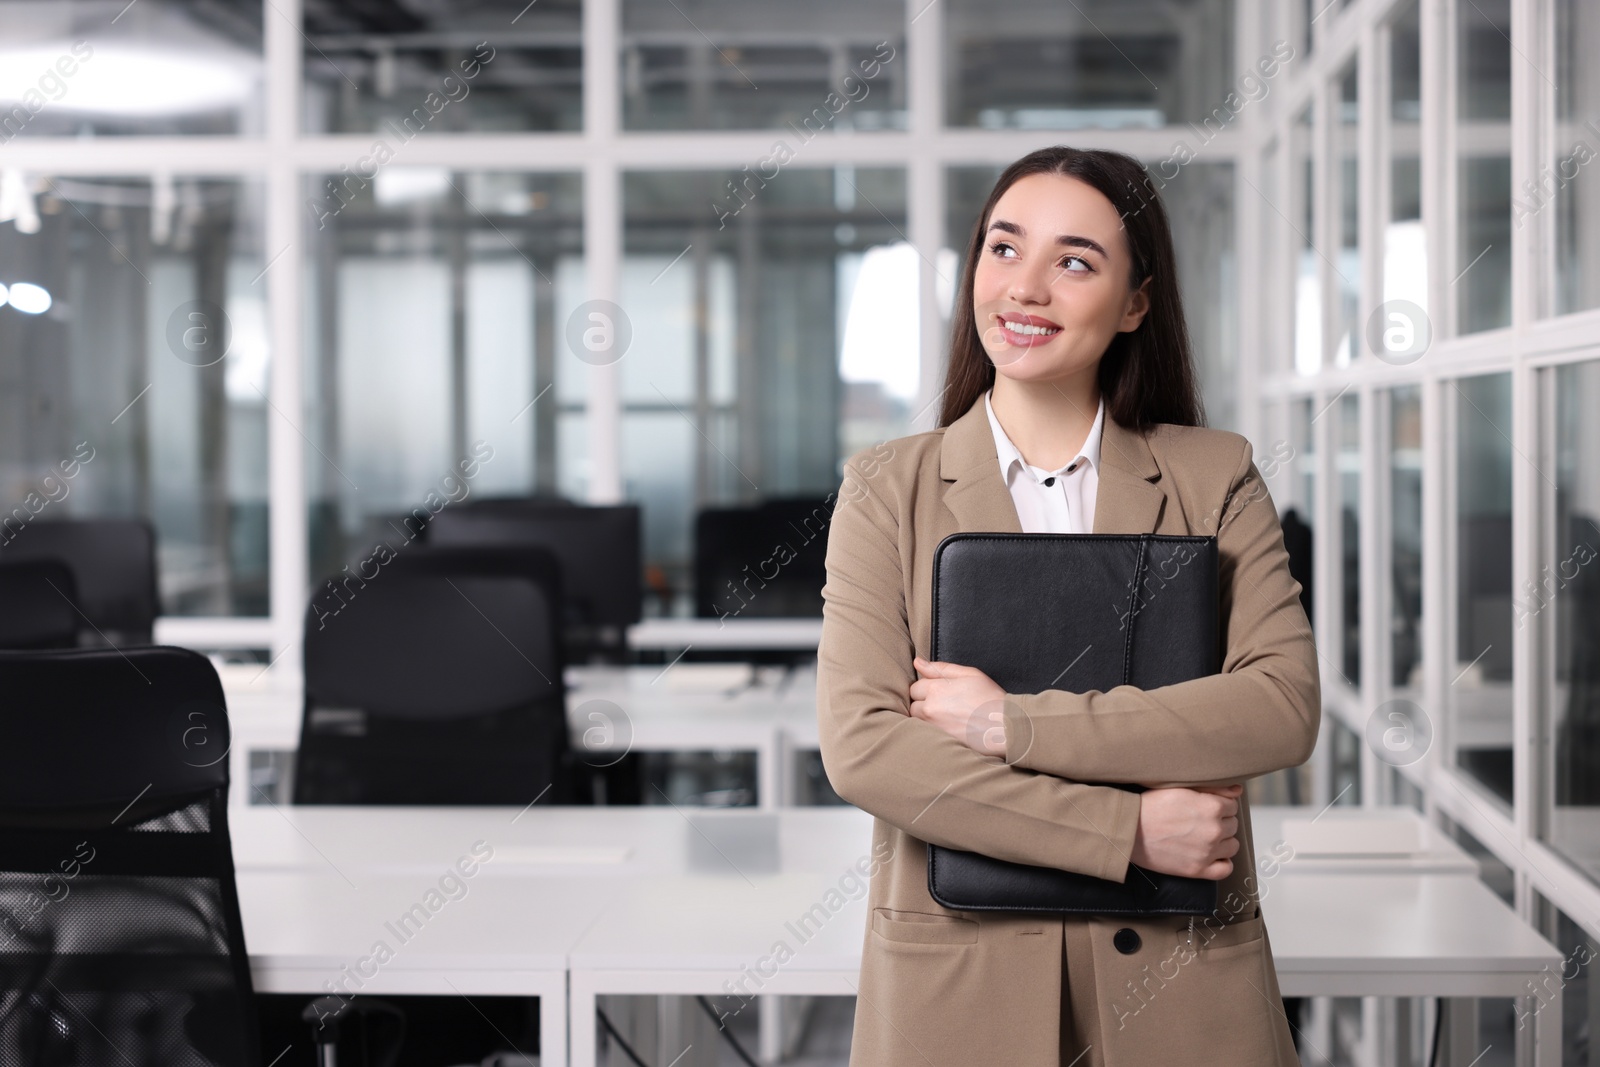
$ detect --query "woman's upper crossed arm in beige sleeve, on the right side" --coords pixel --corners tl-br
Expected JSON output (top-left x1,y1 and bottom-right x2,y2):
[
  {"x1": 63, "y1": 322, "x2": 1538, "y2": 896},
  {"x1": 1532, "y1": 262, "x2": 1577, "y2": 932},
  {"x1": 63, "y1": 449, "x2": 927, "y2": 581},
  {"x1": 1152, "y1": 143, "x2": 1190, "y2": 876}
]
[{"x1": 1005, "y1": 442, "x2": 1322, "y2": 785}]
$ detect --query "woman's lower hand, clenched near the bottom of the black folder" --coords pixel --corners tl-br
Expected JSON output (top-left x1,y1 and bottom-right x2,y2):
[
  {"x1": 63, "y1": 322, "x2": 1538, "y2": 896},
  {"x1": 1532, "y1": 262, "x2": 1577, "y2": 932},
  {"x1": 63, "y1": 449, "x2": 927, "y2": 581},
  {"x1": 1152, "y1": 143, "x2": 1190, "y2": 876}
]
[{"x1": 1133, "y1": 782, "x2": 1245, "y2": 881}]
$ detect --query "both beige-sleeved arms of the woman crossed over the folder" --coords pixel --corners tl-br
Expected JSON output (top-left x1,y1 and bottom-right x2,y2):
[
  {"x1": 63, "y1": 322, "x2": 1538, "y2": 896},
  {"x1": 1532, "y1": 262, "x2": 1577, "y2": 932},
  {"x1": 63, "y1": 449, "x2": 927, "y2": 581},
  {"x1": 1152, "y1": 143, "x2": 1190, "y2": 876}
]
[{"x1": 818, "y1": 446, "x2": 1320, "y2": 881}]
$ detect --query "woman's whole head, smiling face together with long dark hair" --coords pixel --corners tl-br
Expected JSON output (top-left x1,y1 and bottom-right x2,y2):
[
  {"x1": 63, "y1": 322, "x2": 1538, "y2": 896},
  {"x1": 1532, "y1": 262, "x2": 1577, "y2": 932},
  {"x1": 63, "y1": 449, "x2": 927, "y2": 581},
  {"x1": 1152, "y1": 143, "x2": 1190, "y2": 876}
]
[{"x1": 939, "y1": 152, "x2": 1205, "y2": 438}]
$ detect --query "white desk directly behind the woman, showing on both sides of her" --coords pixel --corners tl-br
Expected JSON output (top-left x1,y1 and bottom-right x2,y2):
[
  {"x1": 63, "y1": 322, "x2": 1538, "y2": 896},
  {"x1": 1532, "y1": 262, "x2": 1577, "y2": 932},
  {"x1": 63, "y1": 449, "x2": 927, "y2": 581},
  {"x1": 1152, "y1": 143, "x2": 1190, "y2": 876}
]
[{"x1": 568, "y1": 870, "x2": 1562, "y2": 1067}]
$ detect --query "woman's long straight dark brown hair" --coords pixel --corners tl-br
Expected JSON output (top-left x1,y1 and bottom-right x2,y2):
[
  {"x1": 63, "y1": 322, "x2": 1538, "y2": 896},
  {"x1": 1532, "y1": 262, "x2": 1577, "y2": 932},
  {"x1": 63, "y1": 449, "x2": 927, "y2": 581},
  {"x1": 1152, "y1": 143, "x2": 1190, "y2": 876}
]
[{"x1": 939, "y1": 144, "x2": 1205, "y2": 430}]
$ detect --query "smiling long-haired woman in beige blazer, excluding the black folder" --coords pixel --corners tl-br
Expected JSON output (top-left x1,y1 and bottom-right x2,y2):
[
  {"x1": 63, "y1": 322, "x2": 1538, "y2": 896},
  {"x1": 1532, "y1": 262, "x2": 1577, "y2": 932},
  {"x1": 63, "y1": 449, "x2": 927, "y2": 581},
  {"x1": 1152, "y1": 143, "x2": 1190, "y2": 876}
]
[{"x1": 818, "y1": 147, "x2": 1322, "y2": 1067}]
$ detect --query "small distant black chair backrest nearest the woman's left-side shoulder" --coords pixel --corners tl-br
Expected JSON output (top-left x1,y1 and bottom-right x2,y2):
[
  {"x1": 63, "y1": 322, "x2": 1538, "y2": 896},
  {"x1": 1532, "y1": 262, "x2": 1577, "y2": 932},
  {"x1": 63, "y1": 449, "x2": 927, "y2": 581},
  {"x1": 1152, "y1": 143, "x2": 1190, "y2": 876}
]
[{"x1": 694, "y1": 498, "x2": 834, "y2": 619}]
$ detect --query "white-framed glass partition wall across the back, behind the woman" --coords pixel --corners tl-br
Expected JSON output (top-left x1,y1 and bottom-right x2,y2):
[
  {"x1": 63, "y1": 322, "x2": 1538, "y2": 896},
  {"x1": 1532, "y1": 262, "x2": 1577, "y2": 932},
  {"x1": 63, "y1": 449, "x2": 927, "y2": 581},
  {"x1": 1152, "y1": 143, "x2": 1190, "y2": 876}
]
[{"x1": 0, "y1": 0, "x2": 1241, "y2": 633}]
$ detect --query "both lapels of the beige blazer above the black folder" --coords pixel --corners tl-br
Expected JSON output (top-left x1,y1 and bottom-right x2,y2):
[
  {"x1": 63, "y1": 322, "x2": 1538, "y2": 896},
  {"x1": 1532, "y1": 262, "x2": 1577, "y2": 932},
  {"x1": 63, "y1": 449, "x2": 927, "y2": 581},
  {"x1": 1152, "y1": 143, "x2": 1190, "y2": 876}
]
[{"x1": 939, "y1": 395, "x2": 1166, "y2": 537}]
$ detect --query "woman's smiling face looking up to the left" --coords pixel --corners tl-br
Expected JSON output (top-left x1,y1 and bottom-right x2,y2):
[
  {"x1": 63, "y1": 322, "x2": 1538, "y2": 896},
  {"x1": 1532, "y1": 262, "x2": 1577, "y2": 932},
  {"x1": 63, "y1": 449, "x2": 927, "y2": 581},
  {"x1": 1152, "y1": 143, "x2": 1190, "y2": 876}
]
[{"x1": 973, "y1": 174, "x2": 1149, "y2": 390}]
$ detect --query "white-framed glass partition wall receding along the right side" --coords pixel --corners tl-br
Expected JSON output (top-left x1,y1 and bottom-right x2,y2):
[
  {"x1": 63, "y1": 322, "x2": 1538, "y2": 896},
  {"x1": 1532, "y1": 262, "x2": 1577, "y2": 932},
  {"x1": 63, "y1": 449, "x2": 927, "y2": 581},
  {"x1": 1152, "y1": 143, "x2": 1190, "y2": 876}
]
[{"x1": 1238, "y1": 0, "x2": 1600, "y2": 1064}]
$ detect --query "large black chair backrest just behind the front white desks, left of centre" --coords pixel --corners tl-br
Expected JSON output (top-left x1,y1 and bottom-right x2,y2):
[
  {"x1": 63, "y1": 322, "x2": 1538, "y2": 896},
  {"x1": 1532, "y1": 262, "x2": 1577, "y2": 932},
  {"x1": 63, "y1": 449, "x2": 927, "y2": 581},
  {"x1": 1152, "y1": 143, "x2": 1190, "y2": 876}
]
[{"x1": 294, "y1": 547, "x2": 573, "y2": 805}]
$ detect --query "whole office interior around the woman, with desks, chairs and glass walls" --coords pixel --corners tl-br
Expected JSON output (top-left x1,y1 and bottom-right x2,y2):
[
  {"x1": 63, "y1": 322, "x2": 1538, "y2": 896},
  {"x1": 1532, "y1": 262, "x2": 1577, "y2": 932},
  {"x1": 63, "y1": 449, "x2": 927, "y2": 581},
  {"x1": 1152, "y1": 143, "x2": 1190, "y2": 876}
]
[{"x1": 0, "y1": 0, "x2": 1600, "y2": 1067}]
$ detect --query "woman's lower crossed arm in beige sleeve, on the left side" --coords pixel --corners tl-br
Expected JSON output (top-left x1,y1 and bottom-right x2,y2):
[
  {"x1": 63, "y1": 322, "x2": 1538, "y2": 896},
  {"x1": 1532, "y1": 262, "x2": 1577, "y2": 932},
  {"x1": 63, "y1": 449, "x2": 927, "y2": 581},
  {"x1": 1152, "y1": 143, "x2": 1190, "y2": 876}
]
[{"x1": 818, "y1": 458, "x2": 1139, "y2": 881}]
